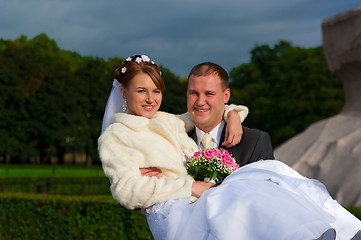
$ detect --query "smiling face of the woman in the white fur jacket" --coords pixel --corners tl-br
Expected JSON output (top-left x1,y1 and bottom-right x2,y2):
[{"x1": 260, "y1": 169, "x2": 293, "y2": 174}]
[{"x1": 121, "y1": 73, "x2": 162, "y2": 118}]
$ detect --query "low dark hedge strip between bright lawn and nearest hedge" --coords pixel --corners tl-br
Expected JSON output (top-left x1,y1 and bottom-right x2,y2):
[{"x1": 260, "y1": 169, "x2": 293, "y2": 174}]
[{"x1": 0, "y1": 176, "x2": 110, "y2": 195}]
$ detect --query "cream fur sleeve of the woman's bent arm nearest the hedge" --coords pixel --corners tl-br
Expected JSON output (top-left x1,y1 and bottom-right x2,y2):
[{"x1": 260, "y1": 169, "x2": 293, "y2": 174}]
[{"x1": 98, "y1": 127, "x2": 193, "y2": 209}]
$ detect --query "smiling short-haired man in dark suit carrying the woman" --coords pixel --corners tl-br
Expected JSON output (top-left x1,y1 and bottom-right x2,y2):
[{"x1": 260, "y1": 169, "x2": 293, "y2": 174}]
[{"x1": 187, "y1": 62, "x2": 274, "y2": 166}]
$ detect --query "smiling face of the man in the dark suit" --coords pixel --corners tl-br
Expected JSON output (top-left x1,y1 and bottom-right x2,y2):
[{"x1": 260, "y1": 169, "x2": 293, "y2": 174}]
[{"x1": 187, "y1": 74, "x2": 230, "y2": 132}]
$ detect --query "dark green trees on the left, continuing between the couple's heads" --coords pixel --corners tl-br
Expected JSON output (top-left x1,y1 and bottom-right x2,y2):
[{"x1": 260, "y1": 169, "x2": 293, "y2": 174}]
[{"x1": 0, "y1": 34, "x2": 186, "y2": 163}]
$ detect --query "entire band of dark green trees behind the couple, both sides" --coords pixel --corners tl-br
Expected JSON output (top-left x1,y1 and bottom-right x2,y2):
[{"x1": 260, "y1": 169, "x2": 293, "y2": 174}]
[{"x1": 0, "y1": 34, "x2": 344, "y2": 163}]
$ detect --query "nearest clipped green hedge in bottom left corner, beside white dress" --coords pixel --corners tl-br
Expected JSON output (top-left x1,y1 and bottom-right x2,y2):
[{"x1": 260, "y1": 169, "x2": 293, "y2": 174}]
[{"x1": 0, "y1": 193, "x2": 153, "y2": 240}]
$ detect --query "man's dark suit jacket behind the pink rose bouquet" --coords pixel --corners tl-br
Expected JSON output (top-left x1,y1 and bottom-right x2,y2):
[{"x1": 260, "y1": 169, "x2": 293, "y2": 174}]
[{"x1": 188, "y1": 125, "x2": 274, "y2": 167}]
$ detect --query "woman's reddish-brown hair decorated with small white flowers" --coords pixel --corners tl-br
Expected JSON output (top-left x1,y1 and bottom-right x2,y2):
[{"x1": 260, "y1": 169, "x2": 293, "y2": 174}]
[{"x1": 115, "y1": 55, "x2": 165, "y2": 93}]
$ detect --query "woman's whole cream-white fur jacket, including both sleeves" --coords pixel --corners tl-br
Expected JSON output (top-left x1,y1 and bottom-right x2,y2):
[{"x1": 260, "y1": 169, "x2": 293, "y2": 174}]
[{"x1": 98, "y1": 105, "x2": 248, "y2": 209}]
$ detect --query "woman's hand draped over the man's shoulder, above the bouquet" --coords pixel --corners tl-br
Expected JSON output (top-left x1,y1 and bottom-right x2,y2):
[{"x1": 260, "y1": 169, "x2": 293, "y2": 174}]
[{"x1": 222, "y1": 111, "x2": 243, "y2": 147}]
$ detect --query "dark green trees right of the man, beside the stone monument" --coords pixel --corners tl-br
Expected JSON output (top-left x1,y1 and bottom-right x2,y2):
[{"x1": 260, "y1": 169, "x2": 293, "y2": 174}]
[{"x1": 230, "y1": 41, "x2": 344, "y2": 146}]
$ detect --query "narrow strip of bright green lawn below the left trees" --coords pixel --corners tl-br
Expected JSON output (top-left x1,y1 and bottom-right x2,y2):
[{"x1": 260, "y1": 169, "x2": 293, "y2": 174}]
[{"x1": 0, "y1": 164, "x2": 104, "y2": 177}]
